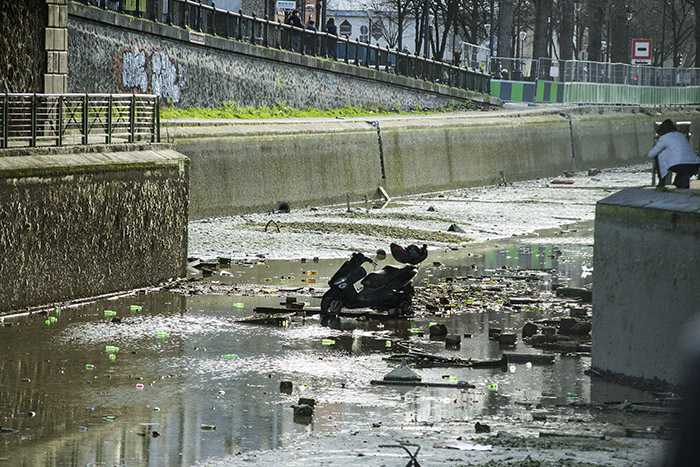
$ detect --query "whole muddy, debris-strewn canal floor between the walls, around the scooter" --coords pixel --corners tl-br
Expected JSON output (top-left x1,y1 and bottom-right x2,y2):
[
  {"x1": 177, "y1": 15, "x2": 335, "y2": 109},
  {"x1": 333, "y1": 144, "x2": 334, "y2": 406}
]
[{"x1": 0, "y1": 167, "x2": 675, "y2": 466}]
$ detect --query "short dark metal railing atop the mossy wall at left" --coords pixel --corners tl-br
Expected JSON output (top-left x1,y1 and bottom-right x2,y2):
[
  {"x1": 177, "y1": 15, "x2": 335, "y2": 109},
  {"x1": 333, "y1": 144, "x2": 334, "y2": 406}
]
[{"x1": 0, "y1": 94, "x2": 160, "y2": 148}]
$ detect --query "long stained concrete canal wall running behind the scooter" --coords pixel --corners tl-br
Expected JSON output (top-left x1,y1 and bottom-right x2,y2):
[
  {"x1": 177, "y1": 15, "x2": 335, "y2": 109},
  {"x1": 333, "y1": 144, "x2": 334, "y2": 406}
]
[{"x1": 171, "y1": 109, "x2": 700, "y2": 218}]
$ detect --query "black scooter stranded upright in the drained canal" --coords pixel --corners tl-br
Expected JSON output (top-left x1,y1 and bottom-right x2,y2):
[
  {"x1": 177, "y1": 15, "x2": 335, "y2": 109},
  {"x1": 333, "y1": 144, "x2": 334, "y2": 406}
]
[{"x1": 321, "y1": 243, "x2": 428, "y2": 324}]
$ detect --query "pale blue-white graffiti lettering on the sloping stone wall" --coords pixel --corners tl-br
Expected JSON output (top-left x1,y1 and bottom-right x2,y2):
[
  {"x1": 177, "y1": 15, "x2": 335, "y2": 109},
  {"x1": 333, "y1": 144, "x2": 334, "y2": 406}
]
[{"x1": 114, "y1": 41, "x2": 186, "y2": 103}]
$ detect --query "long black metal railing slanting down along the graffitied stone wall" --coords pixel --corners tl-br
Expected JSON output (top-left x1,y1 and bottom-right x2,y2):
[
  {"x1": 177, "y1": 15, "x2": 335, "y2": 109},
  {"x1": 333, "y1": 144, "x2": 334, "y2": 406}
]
[{"x1": 76, "y1": 0, "x2": 490, "y2": 94}]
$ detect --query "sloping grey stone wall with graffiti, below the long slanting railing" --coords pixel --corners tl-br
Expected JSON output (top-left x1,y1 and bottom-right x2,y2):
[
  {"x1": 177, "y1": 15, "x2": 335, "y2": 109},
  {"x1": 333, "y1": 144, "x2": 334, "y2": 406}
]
[{"x1": 68, "y1": 3, "x2": 489, "y2": 109}]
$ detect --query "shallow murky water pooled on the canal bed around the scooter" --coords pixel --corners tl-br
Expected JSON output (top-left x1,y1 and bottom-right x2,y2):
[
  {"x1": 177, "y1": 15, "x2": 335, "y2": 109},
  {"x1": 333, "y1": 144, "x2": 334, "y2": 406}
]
[{"x1": 0, "y1": 238, "x2": 656, "y2": 466}]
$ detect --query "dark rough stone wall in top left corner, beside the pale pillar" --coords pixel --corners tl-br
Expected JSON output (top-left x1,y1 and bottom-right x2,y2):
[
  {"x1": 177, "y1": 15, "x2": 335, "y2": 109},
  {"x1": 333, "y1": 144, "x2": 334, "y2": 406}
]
[{"x1": 0, "y1": 0, "x2": 48, "y2": 93}]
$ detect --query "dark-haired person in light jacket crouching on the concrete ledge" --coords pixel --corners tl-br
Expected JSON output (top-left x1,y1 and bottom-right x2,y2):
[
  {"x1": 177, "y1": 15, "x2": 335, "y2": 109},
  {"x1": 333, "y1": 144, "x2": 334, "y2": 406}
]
[{"x1": 649, "y1": 118, "x2": 700, "y2": 188}]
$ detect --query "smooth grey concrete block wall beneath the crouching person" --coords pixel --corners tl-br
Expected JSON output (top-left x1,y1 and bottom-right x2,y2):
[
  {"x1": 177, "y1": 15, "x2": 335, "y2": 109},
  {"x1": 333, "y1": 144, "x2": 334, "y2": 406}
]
[{"x1": 591, "y1": 186, "x2": 700, "y2": 386}]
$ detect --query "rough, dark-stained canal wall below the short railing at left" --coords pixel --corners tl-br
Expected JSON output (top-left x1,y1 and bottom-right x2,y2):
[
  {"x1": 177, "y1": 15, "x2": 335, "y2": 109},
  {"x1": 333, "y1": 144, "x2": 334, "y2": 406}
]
[{"x1": 0, "y1": 145, "x2": 189, "y2": 313}]
